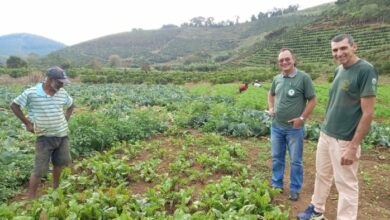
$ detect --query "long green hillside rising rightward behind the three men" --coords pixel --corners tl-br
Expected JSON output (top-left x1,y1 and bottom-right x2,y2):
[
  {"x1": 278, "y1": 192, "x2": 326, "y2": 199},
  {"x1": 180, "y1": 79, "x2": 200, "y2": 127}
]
[{"x1": 42, "y1": 0, "x2": 390, "y2": 67}]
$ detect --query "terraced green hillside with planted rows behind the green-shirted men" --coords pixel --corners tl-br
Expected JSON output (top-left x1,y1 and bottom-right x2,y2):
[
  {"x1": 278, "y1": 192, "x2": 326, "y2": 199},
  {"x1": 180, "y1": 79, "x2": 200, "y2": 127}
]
[{"x1": 229, "y1": 0, "x2": 390, "y2": 66}]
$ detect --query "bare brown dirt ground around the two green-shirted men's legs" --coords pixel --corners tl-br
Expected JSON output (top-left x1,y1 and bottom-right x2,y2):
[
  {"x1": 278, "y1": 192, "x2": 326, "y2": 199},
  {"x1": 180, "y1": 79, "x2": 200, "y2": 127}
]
[{"x1": 276, "y1": 144, "x2": 390, "y2": 220}]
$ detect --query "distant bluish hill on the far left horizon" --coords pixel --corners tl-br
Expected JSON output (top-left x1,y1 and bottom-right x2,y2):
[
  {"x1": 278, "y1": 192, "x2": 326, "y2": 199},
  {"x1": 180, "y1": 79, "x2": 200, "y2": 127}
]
[{"x1": 0, "y1": 33, "x2": 66, "y2": 63}]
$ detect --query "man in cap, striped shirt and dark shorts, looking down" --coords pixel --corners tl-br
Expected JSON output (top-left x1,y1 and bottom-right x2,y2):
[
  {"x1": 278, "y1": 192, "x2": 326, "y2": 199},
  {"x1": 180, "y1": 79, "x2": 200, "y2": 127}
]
[{"x1": 11, "y1": 66, "x2": 74, "y2": 199}]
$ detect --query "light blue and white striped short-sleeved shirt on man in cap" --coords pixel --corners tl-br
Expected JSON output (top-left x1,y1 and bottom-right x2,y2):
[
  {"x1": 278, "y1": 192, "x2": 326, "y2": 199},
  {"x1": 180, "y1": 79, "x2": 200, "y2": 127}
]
[{"x1": 13, "y1": 83, "x2": 73, "y2": 137}]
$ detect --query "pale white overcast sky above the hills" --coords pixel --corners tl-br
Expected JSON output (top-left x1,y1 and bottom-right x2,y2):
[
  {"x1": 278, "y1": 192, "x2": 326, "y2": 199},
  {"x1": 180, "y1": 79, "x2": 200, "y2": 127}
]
[{"x1": 0, "y1": 0, "x2": 335, "y2": 46}]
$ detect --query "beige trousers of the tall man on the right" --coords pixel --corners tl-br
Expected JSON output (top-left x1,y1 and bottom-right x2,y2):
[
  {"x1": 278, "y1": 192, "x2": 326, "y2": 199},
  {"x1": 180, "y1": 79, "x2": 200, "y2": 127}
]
[{"x1": 311, "y1": 132, "x2": 361, "y2": 220}]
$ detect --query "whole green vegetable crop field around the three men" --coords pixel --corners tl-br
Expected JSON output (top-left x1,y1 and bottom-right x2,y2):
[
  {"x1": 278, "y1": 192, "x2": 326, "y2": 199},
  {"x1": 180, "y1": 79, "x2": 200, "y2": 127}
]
[{"x1": 0, "y1": 83, "x2": 390, "y2": 219}]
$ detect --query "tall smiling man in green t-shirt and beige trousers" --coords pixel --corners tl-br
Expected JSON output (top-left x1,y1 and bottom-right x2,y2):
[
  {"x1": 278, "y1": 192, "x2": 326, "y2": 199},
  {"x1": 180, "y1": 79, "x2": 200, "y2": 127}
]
[{"x1": 298, "y1": 34, "x2": 378, "y2": 220}]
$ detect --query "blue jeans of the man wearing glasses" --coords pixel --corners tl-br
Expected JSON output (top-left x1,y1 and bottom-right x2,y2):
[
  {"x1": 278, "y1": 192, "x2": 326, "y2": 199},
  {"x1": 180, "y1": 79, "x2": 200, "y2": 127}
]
[{"x1": 271, "y1": 124, "x2": 305, "y2": 193}]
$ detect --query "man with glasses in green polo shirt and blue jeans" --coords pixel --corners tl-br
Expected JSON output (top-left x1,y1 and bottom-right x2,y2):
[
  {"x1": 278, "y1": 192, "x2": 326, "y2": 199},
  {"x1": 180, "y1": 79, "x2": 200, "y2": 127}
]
[{"x1": 268, "y1": 48, "x2": 316, "y2": 201}]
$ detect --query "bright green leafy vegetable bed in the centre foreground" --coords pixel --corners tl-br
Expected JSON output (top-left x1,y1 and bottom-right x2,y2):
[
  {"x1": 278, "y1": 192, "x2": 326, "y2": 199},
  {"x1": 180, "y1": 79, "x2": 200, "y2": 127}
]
[{"x1": 0, "y1": 134, "x2": 288, "y2": 219}]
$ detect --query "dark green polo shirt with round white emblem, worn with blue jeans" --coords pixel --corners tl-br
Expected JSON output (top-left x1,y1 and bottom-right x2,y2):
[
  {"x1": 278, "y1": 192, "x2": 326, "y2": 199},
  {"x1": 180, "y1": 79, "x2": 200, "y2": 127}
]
[{"x1": 270, "y1": 70, "x2": 315, "y2": 128}]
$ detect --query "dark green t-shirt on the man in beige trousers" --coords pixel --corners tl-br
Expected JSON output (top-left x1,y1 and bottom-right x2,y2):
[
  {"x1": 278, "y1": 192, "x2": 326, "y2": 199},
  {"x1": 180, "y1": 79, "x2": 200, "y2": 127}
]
[{"x1": 322, "y1": 60, "x2": 378, "y2": 141}]
